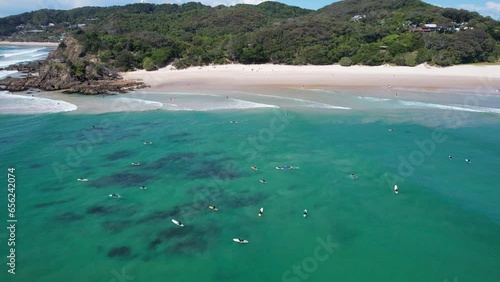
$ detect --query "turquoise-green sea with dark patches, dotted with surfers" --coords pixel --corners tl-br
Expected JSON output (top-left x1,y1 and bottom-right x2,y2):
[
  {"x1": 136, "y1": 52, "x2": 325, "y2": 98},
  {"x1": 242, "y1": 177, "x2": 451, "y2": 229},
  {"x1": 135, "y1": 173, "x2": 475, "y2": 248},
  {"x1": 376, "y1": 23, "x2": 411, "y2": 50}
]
[{"x1": 0, "y1": 109, "x2": 500, "y2": 282}]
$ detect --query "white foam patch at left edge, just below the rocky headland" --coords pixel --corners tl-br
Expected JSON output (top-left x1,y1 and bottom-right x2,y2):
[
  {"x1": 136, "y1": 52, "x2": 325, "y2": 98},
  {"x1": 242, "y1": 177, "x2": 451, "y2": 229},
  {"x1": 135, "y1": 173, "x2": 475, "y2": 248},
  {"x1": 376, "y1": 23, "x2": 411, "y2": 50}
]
[{"x1": 0, "y1": 91, "x2": 78, "y2": 114}]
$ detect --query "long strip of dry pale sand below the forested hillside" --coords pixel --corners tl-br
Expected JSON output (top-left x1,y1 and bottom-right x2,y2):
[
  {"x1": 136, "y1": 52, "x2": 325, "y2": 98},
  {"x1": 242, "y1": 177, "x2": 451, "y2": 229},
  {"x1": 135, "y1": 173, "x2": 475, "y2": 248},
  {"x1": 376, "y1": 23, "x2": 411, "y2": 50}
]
[{"x1": 122, "y1": 64, "x2": 500, "y2": 92}]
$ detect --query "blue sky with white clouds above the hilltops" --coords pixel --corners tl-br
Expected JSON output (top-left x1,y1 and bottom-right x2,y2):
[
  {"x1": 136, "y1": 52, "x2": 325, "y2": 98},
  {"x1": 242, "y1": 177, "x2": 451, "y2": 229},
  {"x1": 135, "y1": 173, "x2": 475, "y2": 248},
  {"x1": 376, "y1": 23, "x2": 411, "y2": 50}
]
[{"x1": 0, "y1": 0, "x2": 500, "y2": 20}]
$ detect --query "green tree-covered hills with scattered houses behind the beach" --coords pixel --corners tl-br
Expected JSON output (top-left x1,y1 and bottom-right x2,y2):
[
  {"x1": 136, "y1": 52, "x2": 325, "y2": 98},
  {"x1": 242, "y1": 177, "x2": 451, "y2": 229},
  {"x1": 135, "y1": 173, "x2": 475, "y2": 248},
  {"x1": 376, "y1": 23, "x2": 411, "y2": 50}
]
[{"x1": 0, "y1": 0, "x2": 500, "y2": 70}]
